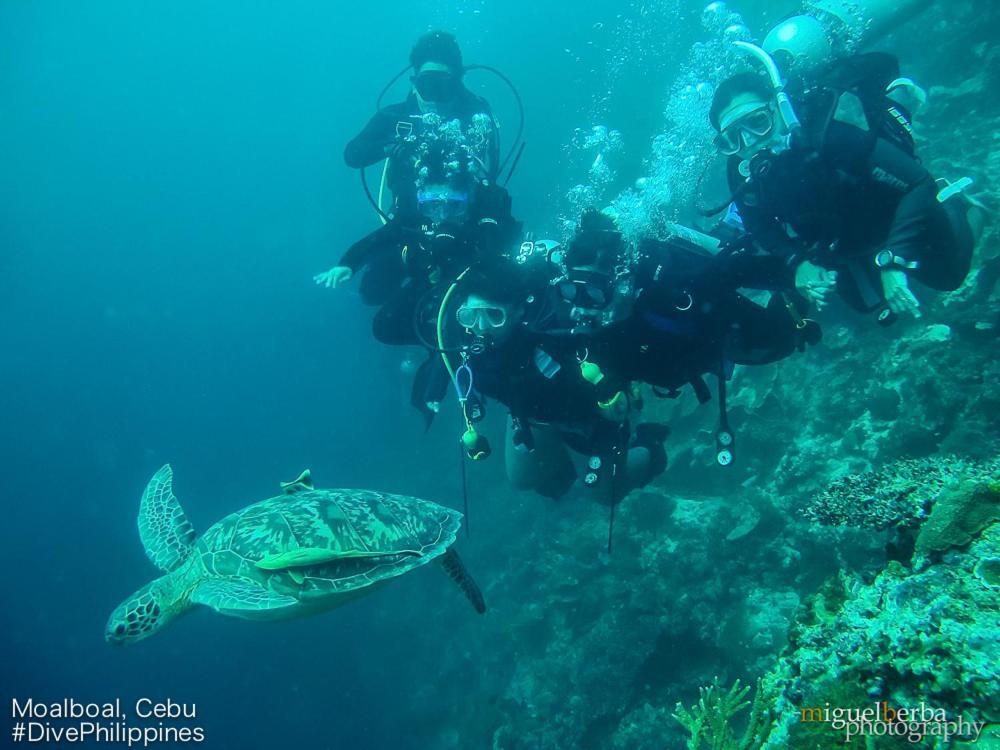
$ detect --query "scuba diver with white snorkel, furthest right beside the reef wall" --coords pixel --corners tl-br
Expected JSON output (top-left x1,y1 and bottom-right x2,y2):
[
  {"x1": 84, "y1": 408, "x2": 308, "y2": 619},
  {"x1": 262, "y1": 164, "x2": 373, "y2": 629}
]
[{"x1": 709, "y1": 48, "x2": 982, "y2": 324}]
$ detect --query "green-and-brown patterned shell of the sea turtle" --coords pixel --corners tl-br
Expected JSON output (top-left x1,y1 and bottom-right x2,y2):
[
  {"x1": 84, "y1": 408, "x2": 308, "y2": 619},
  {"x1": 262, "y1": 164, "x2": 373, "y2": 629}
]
[{"x1": 198, "y1": 490, "x2": 462, "y2": 602}]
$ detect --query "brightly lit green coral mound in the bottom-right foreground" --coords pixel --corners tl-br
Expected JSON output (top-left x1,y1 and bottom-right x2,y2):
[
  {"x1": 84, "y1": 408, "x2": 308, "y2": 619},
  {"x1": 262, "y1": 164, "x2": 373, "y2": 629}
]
[{"x1": 771, "y1": 524, "x2": 1000, "y2": 747}]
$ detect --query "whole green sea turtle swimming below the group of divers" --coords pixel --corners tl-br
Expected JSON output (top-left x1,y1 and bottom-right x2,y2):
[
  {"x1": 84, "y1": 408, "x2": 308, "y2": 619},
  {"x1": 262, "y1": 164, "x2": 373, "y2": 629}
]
[{"x1": 104, "y1": 464, "x2": 486, "y2": 643}]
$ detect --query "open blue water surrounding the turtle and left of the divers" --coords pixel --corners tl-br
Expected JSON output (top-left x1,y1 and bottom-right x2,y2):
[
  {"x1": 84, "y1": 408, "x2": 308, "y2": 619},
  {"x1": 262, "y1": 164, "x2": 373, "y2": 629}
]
[{"x1": 0, "y1": 0, "x2": 988, "y2": 750}]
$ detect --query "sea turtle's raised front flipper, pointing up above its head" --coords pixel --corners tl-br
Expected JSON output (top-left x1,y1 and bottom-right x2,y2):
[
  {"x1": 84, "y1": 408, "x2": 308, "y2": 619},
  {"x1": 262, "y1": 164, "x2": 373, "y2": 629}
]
[{"x1": 139, "y1": 464, "x2": 195, "y2": 573}]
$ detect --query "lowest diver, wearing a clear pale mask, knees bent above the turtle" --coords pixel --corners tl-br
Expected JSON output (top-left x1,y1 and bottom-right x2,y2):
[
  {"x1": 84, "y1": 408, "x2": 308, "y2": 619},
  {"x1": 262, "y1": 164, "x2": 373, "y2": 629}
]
[{"x1": 436, "y1": 253, "x2": 667, "y2": 504}]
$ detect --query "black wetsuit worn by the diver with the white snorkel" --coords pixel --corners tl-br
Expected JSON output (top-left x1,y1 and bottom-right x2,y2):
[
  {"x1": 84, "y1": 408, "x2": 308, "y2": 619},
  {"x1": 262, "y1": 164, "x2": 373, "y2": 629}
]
[{"x1": 729, "y1": 114, "x2": 973, "y2": 311}]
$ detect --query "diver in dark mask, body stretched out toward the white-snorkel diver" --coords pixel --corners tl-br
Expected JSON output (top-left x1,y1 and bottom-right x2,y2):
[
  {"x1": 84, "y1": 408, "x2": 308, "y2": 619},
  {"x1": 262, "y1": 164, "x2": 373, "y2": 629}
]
[{"x1": 544, "y1": 210, "x2": 821, "y2": 466}]
